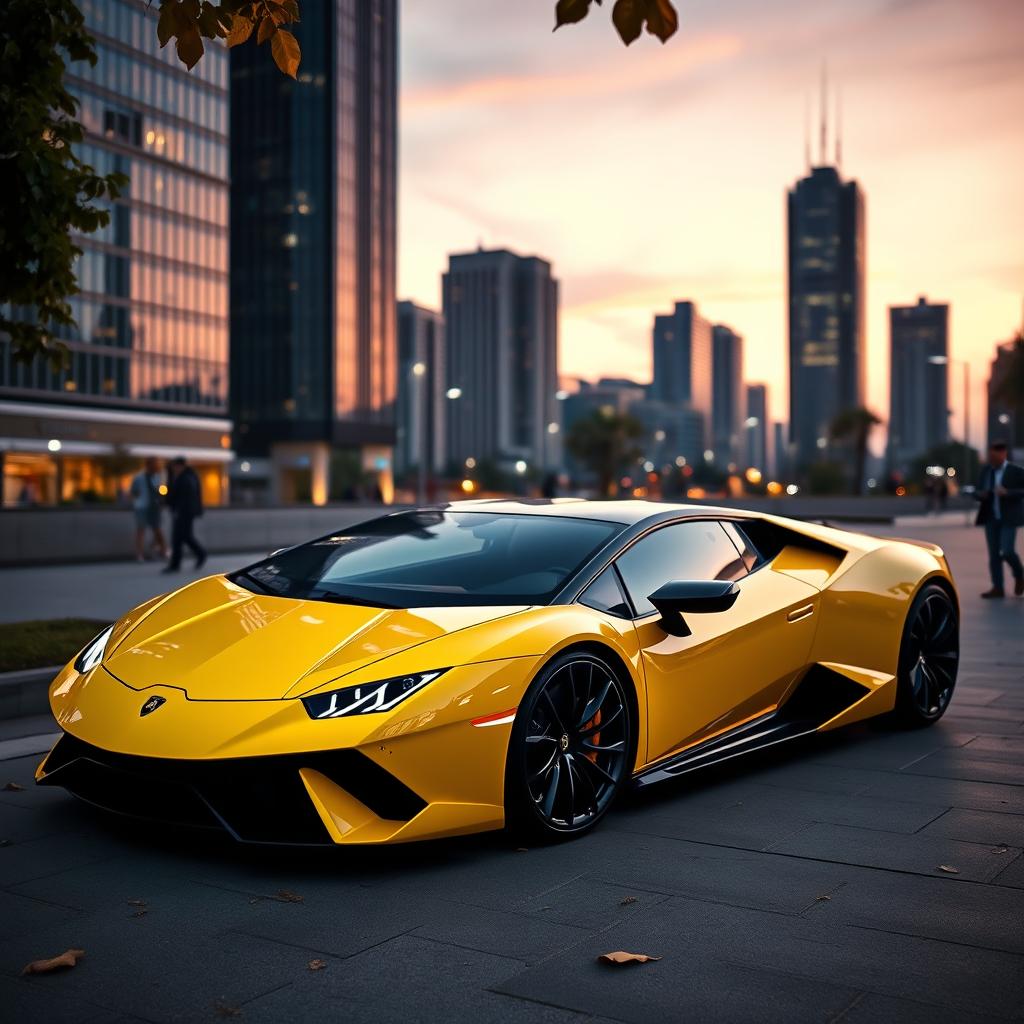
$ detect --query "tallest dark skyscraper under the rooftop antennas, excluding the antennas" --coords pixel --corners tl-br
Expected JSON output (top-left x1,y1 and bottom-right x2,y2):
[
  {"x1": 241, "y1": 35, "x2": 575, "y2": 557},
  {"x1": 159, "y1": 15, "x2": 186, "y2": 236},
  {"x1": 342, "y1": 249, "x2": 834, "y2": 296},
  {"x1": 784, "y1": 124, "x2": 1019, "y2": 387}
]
[{"x1": 787, "y1": 160, "x2": 865, "y2": 471}]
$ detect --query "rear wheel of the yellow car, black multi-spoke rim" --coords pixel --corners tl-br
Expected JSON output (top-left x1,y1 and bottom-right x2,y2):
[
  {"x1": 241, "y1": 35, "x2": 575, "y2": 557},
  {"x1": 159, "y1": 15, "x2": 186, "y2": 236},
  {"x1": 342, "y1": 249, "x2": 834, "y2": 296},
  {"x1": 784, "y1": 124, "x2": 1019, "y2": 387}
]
[{"x1": 895, "y1": 584, "x2": 959, "y2": 728}]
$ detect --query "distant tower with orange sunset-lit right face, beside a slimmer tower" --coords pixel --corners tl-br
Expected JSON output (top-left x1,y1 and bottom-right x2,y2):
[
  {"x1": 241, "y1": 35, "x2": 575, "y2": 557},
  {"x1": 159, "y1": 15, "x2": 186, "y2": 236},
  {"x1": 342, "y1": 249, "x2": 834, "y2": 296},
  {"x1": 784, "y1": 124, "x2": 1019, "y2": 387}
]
[{"x1": 650, "y1": 302, "x2": 712, "y2": 447}]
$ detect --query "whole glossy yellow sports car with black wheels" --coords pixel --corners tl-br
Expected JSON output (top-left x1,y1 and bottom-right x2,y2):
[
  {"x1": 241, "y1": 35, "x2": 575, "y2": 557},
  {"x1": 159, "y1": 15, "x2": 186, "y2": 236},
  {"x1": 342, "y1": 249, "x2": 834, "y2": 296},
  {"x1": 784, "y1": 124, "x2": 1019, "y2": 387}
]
[{"x1": 37, "y1": 501, "x2": 958, "y2": 844}]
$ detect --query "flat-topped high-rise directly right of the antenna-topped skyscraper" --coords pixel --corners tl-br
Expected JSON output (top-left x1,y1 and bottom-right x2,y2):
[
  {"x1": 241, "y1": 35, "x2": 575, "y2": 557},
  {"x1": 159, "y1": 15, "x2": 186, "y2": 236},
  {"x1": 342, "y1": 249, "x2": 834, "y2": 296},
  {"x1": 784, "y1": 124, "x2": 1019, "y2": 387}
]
[{"x1": 888, "y1": 296, "x2": 949, "y2": 472}]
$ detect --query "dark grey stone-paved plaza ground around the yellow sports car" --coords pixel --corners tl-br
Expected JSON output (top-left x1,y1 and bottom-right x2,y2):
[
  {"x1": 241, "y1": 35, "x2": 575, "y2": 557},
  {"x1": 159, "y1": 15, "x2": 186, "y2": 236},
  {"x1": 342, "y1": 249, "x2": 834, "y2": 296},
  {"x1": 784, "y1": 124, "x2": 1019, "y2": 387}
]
[{"x1": 0, "y1": 516, "x2": 1024, "y2": 1024}]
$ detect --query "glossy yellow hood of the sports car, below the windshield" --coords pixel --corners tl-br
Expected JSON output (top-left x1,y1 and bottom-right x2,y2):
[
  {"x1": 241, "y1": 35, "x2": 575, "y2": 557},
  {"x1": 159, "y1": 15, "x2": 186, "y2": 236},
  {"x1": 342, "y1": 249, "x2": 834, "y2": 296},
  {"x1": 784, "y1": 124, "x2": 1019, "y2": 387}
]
[{"x1": 103, "y1": 577, "x2": 524, "y2": 700}]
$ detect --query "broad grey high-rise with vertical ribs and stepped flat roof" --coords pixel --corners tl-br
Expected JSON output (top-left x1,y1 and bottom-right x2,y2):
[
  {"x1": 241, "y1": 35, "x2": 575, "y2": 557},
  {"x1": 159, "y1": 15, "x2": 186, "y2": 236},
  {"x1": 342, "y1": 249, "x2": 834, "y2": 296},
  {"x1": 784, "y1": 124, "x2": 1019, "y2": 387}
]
[{"x1": 442, "y1": 249, "x2": 561, "y2": 470}]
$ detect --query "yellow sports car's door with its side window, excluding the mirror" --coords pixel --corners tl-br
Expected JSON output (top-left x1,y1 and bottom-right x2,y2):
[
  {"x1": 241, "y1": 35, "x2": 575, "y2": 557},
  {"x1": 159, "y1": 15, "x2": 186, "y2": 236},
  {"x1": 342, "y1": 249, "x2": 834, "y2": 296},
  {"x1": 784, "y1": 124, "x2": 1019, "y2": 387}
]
[{"x1": 615, "y1": 519, "x2": 819, "y2": 763}]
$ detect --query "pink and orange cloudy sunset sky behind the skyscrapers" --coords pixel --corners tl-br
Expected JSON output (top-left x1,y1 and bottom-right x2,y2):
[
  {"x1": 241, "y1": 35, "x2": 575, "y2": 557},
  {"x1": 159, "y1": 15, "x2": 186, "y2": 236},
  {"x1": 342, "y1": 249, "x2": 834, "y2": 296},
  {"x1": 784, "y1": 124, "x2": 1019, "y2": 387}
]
[{"x1": 398, "y1": 0, "x2": 1024, "y2": 443}]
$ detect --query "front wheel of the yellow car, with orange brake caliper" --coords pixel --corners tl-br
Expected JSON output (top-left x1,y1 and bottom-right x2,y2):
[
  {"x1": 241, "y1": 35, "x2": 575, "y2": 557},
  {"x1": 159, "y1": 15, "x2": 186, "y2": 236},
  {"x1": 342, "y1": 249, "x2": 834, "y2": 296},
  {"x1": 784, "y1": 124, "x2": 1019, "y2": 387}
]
[{"x1": 505, "y1": 651, "x2": 636, "y2": 842}]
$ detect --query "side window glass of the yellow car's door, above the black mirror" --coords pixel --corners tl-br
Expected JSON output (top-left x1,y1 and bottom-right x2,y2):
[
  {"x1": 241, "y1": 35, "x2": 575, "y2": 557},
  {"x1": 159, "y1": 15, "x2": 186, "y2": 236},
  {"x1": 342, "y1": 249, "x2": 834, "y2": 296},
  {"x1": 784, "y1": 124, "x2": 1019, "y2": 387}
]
[{"x1": 616, "y1": 521, "x2": 746, "y2": 615}]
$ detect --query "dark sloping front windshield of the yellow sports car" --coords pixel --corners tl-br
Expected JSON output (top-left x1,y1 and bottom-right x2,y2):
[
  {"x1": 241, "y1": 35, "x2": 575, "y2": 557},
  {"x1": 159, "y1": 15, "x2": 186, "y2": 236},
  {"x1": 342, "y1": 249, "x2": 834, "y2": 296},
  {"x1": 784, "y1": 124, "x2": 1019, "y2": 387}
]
[{"x1": 232, "y1": 510, "x2": 623, "y2": 608}]
